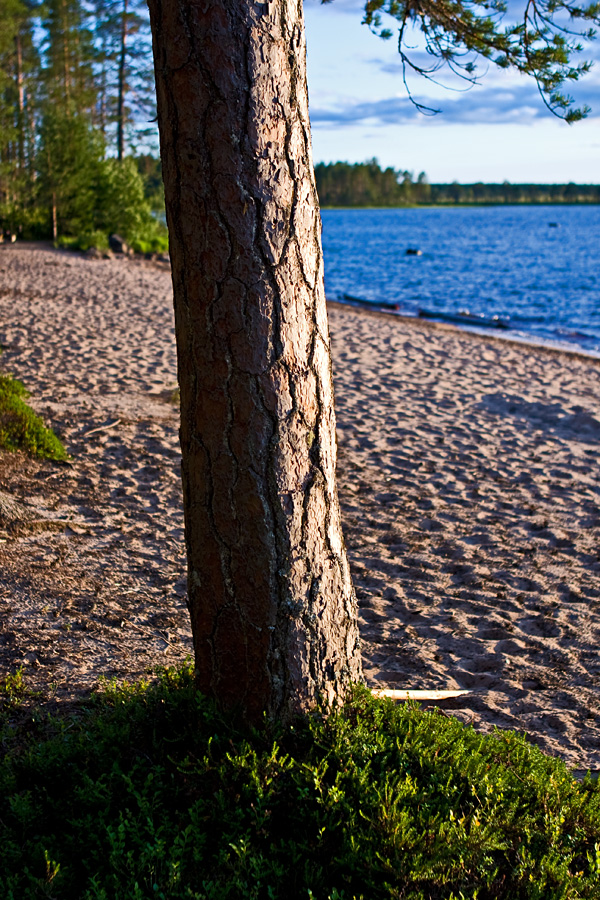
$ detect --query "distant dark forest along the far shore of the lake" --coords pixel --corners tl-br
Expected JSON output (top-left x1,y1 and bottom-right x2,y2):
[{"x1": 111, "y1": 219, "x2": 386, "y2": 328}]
[{"x1": 315, "y1": 159, "x2": 600, "y2": 207}]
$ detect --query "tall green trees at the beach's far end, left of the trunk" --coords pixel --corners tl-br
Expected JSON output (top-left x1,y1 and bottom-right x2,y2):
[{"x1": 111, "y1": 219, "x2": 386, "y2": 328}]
[{"x1": 0, "y1": 0, "x2": 165, "y2": 248}]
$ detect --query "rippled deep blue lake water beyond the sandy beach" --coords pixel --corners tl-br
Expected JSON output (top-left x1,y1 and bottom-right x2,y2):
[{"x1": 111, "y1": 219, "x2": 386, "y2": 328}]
[{"x1": 322, "y1": 206, "x2": 600, "y2": 355}]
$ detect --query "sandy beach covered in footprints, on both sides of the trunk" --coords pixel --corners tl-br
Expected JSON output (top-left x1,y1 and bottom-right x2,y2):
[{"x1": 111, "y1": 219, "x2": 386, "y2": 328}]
[{"x1": 0, "y1": 244, "x2": 600, "y2": 771}]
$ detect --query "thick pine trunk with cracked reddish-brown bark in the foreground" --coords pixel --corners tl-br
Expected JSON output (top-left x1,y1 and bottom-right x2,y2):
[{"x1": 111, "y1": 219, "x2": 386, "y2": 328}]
[{"x1": 149, "y1": 0, "x2": 361, "y2": 720}]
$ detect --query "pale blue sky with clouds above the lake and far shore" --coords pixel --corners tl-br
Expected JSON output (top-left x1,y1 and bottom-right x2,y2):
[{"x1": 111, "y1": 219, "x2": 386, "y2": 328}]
[{"x1": 304, "y1": 0, "x2": 600, "y2": 184}]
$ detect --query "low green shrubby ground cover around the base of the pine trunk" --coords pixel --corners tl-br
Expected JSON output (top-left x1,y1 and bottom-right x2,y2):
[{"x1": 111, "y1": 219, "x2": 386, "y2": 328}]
[{"x1": 0, "y1": 669, "x2": 600, "y2": 900}]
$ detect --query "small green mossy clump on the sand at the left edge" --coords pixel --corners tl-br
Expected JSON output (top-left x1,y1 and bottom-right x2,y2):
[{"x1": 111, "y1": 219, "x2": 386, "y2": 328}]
[{"x1": 0, "y1": 375, "x2": 67, "y2": 460}]
